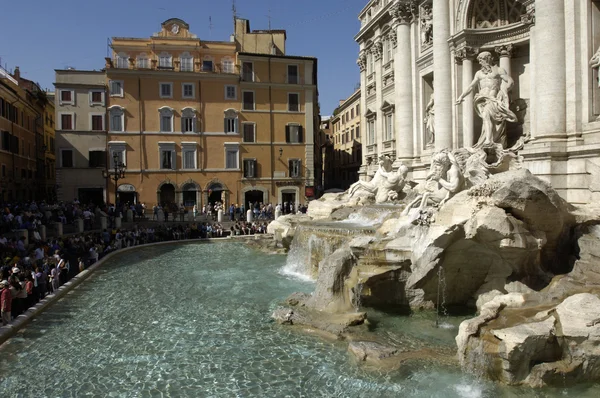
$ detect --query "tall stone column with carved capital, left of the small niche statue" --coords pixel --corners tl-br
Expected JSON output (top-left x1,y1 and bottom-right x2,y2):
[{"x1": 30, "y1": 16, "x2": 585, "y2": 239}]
[{"x1": 390, "y1": 2, "x2": 416, "y2": 160}]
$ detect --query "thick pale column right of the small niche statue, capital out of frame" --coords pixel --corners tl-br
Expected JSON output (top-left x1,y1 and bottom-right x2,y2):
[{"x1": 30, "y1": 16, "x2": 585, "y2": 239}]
[{"x1": 433, "y1": 0, "x2": 452, "y2": 150}]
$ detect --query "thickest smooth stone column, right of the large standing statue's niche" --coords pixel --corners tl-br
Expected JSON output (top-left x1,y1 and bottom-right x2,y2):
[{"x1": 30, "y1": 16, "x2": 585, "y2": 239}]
[{"x1": 532, "y1": 0, "x2": 566, "y2": 139}]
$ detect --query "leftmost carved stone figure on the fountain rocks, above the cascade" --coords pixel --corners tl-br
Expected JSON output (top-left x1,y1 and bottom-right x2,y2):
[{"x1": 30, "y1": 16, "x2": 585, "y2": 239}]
[{"x1": 348, "y1": 155, "x2": 408, "y2": 203}]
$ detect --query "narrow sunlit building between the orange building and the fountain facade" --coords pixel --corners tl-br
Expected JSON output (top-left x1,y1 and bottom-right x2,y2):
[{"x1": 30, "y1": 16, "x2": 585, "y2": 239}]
[{"x1": 329, "y1": 89, "x2": 362, "y2": 190}]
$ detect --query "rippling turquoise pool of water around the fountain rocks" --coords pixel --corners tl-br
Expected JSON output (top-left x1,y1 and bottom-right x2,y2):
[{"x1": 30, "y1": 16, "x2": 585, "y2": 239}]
[{"x1": 0, "y1": 242, "x2": 600, "y2": 398}]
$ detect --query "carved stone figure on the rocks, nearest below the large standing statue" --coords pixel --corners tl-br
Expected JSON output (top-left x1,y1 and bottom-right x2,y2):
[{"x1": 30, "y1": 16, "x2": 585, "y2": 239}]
[{"x1": 402, "y1": 150, "x2": 465, "y2": 215}]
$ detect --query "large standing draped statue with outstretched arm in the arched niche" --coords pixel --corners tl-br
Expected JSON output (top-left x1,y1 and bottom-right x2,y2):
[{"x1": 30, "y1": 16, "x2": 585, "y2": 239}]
[{"x1": 456, "y1": 51, "x2": 517, "y2": 148}]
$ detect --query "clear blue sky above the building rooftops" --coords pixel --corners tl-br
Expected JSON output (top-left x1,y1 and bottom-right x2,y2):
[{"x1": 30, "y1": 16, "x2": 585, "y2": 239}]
[{"x1": 0, "y1": 0, "x2": 368, "y2": 115}]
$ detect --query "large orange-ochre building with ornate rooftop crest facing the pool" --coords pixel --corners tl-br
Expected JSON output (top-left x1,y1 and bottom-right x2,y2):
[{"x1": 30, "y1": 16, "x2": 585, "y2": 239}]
[{"x1": 106, "y1": 18, "x2": 319, "y2": 207}]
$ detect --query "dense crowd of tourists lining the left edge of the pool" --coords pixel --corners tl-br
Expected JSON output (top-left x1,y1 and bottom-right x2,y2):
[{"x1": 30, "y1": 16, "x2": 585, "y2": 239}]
[{"x1": 0, "y1": 202, "x2": 268, "y2": 325}]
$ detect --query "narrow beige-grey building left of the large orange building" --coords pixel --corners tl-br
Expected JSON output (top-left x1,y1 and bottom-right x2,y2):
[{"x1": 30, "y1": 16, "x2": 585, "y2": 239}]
[{"x1": 49, "y1": 69, "x2": 107, "y2": 203}]
